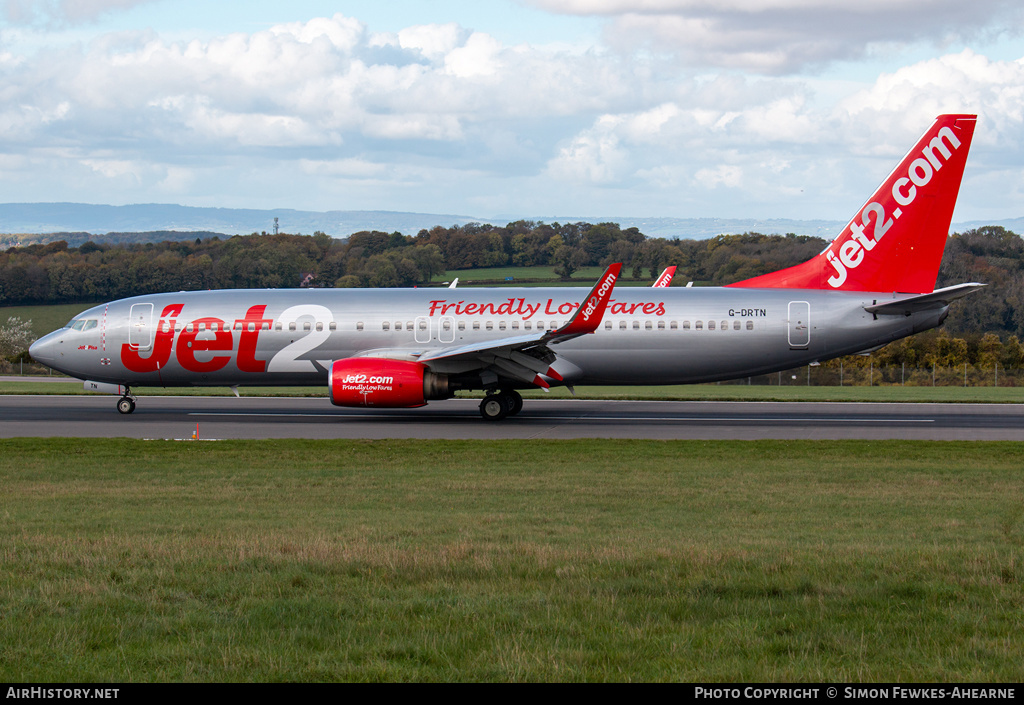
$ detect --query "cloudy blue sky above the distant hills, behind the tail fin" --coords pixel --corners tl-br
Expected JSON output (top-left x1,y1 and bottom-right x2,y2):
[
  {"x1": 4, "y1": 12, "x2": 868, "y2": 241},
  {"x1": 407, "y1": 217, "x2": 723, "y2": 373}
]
[{"x1": 0, "y1": 0, "x2": 1024, "y2": 221}]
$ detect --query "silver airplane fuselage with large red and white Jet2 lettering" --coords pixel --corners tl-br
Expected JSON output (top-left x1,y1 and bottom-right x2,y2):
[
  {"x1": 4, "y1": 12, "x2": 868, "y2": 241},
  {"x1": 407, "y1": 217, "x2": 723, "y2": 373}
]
[{"x1": 32, "y1": 287, "x2": 948, "y2": 386}]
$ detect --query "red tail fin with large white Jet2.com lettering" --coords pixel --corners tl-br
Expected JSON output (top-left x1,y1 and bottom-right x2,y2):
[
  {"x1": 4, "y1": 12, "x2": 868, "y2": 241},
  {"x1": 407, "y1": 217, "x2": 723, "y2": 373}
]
[{"x1": 730, "y1": 115, "x2": 977, "y2": 294}]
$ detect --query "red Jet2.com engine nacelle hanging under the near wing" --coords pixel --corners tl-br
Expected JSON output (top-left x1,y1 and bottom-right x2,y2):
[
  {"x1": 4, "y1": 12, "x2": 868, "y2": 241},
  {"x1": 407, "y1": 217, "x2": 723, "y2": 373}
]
[{"x1": 329, "y1": 358, "x2": 451, "y2": 408}]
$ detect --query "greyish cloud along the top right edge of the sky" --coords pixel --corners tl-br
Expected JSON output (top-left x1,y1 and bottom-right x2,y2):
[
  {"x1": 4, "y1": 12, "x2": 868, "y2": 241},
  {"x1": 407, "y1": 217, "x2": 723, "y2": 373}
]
[{"x1": 529, "y1": 0, "x2": 1024, "y2": 74}]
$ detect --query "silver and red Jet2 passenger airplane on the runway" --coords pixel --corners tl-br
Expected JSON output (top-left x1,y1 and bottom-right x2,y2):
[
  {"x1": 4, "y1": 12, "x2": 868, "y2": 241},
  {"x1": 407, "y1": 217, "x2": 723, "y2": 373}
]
[{"x1": 30, "y1": 115, "x2": 984, "y2": 421}]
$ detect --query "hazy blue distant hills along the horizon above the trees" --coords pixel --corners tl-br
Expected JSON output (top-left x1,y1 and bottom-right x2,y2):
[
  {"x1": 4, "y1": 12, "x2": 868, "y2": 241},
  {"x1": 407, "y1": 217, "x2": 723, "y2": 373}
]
[{"x1": 0, "y1": 203, "x2": 1024, "y2": 248}]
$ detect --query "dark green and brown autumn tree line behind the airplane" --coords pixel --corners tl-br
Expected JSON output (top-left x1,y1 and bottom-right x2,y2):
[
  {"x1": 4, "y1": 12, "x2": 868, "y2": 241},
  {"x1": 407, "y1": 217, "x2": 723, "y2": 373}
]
[{"x1": 0, "y1": 220, "x2": 1024, "y2": 346}]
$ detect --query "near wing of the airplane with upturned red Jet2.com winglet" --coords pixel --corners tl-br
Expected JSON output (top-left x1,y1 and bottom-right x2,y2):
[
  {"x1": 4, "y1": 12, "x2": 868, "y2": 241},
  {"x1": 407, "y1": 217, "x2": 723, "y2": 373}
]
[{"x1": 360, "y1": 263, "x2": 623, "y2": 388}]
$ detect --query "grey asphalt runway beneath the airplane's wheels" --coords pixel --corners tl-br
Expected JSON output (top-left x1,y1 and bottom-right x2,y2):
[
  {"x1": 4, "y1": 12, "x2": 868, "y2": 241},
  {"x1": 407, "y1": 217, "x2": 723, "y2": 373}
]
[{"x1": 0, "y1": 396, "x2": 1024, "y2": 441}]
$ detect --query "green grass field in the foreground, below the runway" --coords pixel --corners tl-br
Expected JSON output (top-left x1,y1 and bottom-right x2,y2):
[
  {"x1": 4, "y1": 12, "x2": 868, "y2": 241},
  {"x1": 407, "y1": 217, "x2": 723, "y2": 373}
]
[{"x1": 0, "y1": 440, "x2": 1024, "y2": 682}]
